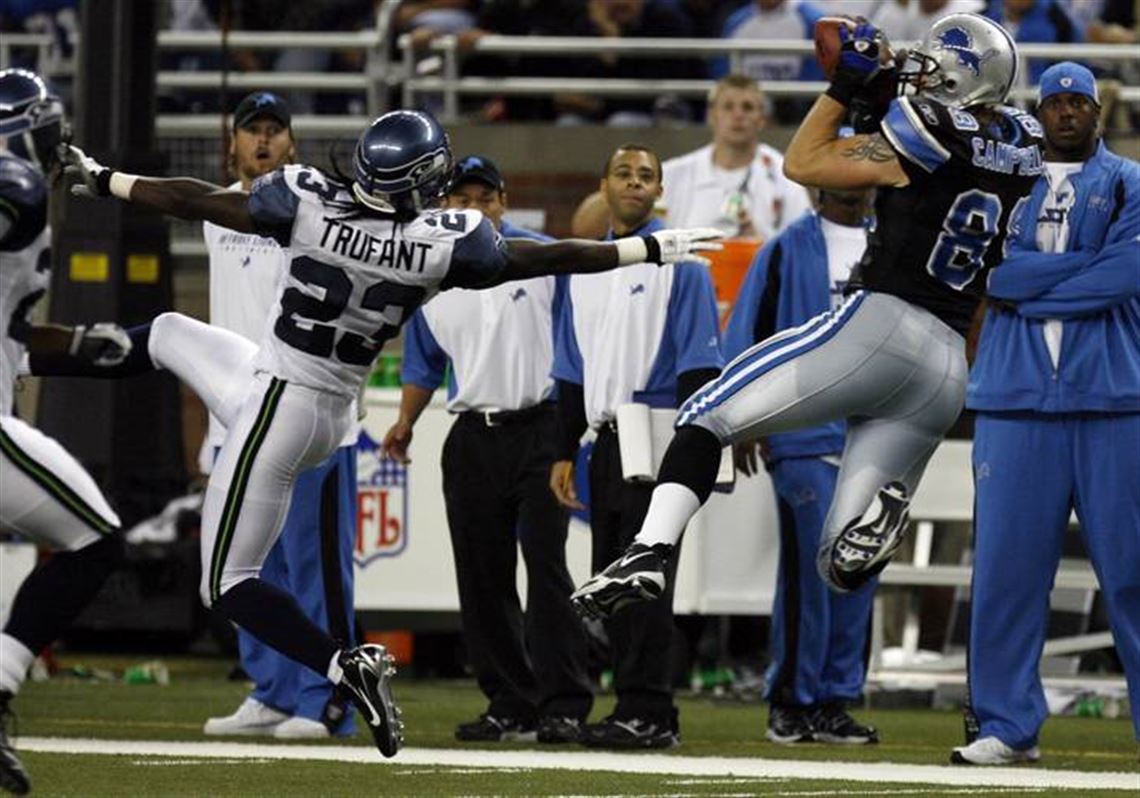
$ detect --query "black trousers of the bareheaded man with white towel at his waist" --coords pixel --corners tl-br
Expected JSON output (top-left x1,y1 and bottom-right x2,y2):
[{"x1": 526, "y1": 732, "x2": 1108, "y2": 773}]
[{"x1": 589, "y1": 426, "x2": 681, "y2": 723}]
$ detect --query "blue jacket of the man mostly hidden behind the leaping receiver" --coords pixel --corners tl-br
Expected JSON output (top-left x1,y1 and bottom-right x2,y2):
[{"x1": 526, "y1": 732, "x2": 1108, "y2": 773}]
[{"x1": 724, "y1": 211, "x2": 847, "y2": 462}]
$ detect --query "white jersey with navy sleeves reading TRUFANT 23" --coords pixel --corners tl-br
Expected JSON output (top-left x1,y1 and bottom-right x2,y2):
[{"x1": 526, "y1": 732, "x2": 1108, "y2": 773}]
[{"x1": 249, "y1": 165, "x2": 505, "y2": 394}]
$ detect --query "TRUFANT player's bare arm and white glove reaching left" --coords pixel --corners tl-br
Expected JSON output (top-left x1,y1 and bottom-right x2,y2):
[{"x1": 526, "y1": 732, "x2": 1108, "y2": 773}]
[{"x1": 63, "y1": 146, "x2": 257, "y2": 233}]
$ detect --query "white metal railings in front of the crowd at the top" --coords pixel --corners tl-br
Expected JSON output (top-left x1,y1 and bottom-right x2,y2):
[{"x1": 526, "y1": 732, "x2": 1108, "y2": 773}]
[{"x1": 0, "y1": 19, "x2": 1140, "y2": 136}]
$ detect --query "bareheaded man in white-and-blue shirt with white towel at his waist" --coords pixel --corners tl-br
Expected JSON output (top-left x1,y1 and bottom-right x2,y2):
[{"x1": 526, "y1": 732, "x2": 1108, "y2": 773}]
[{"x1": 551, "y1": 144, "x2": 723, "y2": 749}]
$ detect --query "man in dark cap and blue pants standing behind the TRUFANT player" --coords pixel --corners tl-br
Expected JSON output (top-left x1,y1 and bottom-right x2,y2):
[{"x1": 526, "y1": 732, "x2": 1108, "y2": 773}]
[{"x1": 198, "y1": 91, "x2": 360, "y2": 739}]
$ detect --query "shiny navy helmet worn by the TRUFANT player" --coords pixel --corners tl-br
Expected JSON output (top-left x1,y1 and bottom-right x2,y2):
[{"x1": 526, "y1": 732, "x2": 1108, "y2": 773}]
[{"x1": 352, "y1": 111, "x2": 451, "y2": 215}]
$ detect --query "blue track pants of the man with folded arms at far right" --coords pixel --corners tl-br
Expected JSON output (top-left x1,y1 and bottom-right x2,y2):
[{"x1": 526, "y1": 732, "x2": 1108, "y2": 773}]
[{"x1": 969, "y1": 412, "x2": 1140, "y2": 749}]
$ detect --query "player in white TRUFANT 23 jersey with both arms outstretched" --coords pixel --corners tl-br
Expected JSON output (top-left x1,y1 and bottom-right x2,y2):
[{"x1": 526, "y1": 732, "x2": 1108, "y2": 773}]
[{"x1": 55, "y1": 111, "x2": 719, "y2": 756}]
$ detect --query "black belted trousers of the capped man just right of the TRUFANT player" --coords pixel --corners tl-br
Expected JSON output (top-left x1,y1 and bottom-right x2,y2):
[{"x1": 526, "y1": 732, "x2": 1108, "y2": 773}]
[{"x1": 442, "y1": 405, "x2": 593, "y2": 720}]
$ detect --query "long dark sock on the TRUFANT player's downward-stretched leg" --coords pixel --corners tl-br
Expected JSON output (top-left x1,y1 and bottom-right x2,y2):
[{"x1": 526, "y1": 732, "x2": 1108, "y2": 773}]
[{"x1": 214, "y1": 579, "x2": 341, "y2": 676}]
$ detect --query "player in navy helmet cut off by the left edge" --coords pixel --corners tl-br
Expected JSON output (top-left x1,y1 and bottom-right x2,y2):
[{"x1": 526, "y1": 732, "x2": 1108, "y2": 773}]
[{"x1": 0, "y1": 70, "x2": 131, "y2": 795}]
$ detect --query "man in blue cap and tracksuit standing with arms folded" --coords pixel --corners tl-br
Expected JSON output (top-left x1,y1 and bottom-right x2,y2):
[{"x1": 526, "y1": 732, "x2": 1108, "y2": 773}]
[{"x1": 952, "y1": 62, "x2": 1140, "y2": 765}]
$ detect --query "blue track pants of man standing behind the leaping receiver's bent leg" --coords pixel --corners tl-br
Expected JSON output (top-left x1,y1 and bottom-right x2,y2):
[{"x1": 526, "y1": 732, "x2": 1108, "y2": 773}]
[{"x1": 765, "y1": 457, "x2": 877, "y2": 707}]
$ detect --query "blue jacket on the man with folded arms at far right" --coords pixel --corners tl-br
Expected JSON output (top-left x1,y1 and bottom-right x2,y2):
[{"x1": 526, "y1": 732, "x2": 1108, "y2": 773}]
[{"x1": 967, "y1": 143, "x2": 1140, "y2": 413}]
